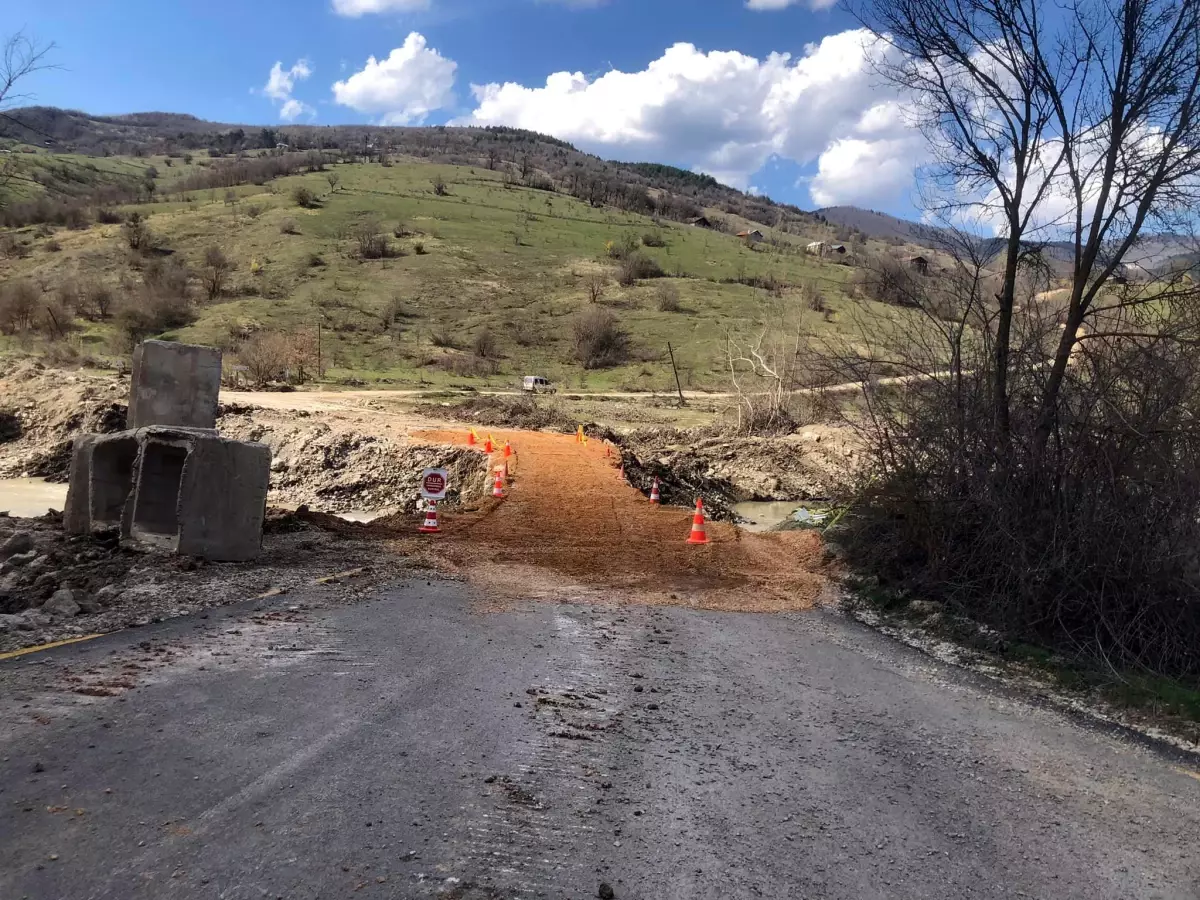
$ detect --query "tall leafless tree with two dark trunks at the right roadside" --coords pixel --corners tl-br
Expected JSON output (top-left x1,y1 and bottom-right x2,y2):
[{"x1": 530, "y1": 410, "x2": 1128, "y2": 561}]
[{"x1": 854, "y1": 0, "x2": 1200, "y2": 451}]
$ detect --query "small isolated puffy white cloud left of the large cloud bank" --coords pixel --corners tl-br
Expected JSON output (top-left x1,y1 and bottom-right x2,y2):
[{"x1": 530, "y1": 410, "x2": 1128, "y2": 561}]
[{"x1": 334, "y1": 31, "x2": 458, "y2": 125}]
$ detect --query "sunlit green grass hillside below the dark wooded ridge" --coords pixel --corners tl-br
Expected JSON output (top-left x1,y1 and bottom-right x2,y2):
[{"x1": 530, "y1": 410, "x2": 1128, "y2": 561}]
[{"x1": 0, "y1": 150, "x2": 926, "y2": 390}]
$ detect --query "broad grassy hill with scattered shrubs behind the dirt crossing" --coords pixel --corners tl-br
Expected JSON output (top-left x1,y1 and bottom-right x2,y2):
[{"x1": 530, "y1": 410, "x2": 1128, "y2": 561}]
[{"x1": 0, "y1": 142, "x2": 917, "y2": 390}]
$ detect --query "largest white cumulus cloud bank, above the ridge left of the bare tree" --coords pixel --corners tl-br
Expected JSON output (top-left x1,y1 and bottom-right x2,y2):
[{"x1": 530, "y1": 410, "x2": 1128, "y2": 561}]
[{"x1": 458, "y1": 30, "x2": 922, "y2": 205}]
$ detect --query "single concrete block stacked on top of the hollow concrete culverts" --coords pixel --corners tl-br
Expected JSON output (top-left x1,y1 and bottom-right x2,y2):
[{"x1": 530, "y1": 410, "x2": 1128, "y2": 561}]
[{"x1": 128, "y1": 341, "x2": 221, "y2": 428}]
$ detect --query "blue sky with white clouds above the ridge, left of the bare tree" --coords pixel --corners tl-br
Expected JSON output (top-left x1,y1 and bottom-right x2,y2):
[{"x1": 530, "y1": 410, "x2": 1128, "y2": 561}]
[{"x1": 5, "y1": 0, "x2": 922, "y2": 214}]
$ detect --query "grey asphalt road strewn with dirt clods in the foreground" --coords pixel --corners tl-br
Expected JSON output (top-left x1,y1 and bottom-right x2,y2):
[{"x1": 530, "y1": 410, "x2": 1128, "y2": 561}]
[{"x1": 0, "y1": 580, "x2": 1200, "y2": 900}]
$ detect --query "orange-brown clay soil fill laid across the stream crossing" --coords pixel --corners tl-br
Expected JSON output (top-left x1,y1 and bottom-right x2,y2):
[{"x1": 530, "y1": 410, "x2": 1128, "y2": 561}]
[{"x1": 386, "y1": 431, "x2": 827, "y2": 611}]
